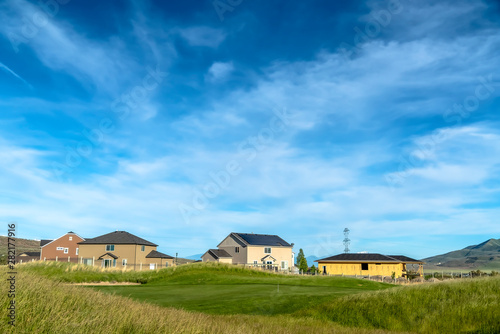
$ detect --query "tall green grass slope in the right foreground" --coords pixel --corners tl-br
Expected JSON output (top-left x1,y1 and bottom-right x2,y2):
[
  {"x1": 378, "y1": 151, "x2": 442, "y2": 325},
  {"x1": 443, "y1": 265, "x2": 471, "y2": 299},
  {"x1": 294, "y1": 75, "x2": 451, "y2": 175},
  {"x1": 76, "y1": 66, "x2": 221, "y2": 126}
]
[{"x1": 299, "y1": 277, "x2": 500, "y2": 333}]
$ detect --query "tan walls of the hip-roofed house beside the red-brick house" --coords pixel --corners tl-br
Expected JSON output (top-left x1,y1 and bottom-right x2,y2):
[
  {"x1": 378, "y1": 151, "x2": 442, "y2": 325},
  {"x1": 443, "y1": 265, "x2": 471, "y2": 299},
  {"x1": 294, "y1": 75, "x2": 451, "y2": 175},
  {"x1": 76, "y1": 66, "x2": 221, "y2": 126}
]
[{"x1": 79, "y1": 244, "x2": 158, "y2": 270}]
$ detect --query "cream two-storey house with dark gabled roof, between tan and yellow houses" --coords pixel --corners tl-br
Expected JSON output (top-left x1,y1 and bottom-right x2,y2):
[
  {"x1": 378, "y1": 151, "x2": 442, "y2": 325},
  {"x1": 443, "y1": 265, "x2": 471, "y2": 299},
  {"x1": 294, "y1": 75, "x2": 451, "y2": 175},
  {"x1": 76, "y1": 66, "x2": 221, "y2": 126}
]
[{"x1": 201, "y1": 233, "x2": 295, "y2": 270}]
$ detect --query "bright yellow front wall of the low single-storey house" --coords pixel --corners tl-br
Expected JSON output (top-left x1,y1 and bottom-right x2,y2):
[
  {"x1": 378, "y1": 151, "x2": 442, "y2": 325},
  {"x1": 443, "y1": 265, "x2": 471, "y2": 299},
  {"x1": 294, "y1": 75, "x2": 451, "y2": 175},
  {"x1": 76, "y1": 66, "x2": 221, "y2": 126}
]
[{"x1": 318, "y1": 262, "x2": 403, "y2": 277}]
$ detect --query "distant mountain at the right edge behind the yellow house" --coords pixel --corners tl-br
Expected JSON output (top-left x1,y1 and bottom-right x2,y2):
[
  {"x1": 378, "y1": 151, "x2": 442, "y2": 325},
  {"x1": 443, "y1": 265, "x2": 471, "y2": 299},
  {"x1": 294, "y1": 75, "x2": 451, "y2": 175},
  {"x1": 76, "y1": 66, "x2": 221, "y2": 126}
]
[{"x1": 423, "y1": 239, "x2": 500, "y2": 270}]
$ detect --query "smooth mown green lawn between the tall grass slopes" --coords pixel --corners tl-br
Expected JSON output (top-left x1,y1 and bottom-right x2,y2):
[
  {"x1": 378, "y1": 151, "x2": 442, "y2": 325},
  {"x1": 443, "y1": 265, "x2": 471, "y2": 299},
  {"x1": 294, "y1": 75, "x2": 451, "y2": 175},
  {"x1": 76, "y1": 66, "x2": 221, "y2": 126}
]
[{"x1": 94, "y1": 282, "x2": 382, "y2": 315}]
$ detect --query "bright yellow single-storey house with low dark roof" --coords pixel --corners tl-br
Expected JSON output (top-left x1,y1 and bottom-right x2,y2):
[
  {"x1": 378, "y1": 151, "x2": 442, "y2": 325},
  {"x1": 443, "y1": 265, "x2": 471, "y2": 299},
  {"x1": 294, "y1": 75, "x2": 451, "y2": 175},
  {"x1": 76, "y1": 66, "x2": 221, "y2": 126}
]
[{"x1": 314, "y1": 253, "x2": 423, "y2": 278}]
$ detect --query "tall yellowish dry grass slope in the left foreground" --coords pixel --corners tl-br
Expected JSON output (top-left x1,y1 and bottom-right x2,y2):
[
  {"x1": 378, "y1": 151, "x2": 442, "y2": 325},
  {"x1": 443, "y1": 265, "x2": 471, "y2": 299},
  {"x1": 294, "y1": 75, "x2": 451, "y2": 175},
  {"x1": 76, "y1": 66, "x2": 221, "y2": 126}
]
[{"x1": 0, "y1": 268, "x2": 383, "y2": 334}]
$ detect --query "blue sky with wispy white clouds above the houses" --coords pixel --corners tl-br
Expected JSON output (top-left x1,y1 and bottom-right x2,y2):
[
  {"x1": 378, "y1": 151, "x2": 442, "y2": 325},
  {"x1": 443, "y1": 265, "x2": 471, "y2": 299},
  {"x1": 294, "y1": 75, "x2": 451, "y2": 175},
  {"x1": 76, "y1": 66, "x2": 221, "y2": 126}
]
[{"x1": 0, "y1": 0, "x2": 500, "y2": 258}]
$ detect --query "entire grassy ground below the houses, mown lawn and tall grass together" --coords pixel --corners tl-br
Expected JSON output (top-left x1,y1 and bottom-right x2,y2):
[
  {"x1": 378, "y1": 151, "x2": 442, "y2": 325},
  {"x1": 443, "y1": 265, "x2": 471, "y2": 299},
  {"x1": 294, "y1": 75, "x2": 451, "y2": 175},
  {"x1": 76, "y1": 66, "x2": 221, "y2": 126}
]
[{"x1": 0, "y1": 264, "x2": 500, "y2": 333}]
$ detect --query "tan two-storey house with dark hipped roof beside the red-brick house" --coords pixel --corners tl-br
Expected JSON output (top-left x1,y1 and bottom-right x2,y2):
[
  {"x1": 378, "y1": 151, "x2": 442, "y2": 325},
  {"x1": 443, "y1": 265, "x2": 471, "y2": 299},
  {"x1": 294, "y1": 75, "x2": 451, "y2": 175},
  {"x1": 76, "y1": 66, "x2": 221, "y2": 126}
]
[{"x1": 78, "y1": 231, "x2": 174, "y2": 270}]
